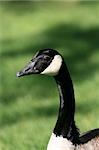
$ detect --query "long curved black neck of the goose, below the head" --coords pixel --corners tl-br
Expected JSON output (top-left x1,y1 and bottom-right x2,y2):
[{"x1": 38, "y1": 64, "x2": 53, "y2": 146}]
[{"x1": 54, "y1": 63, "x2": 78, "y2": 141}]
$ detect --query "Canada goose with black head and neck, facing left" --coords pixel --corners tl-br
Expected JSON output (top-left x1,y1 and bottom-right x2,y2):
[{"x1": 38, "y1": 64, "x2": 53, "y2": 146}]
[{"x1": 17, "y1": 48, "x2": 99, "y2": 150}]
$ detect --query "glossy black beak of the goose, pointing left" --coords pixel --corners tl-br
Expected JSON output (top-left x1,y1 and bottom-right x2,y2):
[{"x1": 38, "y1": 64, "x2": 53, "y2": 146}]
[{"x1": 16, "y1": 61, "x2": 39, "y2": 77}]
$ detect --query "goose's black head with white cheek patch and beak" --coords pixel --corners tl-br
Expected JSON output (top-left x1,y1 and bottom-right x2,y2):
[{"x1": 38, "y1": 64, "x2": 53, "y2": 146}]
[{"x1": 17, "y1": 49, "x2": 63, "y2": 77}]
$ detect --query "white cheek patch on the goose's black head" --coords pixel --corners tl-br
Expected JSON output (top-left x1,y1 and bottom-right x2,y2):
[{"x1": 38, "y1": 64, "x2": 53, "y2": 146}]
[{"x1": 41, "y1": 55, "x2": 62, "y2": 76}]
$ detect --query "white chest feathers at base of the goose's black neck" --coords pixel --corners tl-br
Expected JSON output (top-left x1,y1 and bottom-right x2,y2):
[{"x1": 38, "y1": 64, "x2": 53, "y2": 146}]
[{"x1": 47, "y1": 133, "x2": 75, "y2": 150}]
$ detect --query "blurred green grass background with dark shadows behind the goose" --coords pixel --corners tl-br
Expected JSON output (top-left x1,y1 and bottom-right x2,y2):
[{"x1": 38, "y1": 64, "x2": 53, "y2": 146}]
[{"x1": 0, "y1": 1, "x2": 99, "y2": 150}]
